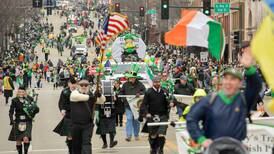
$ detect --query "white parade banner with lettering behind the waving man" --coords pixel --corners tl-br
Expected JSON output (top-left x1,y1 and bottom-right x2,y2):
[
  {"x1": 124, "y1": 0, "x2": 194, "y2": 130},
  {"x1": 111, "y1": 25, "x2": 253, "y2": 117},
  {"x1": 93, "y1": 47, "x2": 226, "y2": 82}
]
[{"x1": 176, "y1": 117, "x2": 274, "y2": 154}]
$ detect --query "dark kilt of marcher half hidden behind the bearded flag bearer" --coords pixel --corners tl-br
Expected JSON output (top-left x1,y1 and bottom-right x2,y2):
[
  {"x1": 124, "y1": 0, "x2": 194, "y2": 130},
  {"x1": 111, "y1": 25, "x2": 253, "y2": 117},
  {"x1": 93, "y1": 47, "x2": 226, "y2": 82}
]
[{"x1": 53, "y1": 117, "x2": 72, "y2": 136}]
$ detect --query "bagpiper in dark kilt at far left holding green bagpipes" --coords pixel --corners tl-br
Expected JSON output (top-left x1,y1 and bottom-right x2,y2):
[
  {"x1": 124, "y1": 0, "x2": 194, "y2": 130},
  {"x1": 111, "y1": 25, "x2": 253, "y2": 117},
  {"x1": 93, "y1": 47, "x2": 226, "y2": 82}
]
[{"x1": 8, "y1": 87, "x2": 39, "y2": 154}]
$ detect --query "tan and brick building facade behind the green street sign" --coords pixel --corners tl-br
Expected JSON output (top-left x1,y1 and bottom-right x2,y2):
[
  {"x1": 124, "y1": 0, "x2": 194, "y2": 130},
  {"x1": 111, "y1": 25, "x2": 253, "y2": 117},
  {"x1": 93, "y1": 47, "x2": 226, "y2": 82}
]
[{"x1": 211, "y1": 0, "x2": 266, "y2": 63}]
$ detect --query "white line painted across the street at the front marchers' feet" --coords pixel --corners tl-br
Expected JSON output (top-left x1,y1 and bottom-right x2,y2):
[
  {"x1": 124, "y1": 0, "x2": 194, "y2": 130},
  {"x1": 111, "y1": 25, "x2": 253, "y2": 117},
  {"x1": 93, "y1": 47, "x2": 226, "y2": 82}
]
[{"x1": 0, "y1": 146, "x2": 149, "y2": 154}]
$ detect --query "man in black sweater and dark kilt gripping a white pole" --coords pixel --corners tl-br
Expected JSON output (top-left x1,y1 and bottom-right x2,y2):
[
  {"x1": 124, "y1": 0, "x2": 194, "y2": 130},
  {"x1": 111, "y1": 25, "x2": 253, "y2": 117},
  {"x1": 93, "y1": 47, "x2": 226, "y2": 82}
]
[{"x1": 140, "y1": 77, "x2": 174, "y2": 154}]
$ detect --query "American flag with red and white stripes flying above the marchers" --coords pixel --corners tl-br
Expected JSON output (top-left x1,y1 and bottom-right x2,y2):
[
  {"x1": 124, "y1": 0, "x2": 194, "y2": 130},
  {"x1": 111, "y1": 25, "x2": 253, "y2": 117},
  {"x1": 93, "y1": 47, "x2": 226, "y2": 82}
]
[{"x1": 96, "y1": 13, "x2": 129, "y2": 47}]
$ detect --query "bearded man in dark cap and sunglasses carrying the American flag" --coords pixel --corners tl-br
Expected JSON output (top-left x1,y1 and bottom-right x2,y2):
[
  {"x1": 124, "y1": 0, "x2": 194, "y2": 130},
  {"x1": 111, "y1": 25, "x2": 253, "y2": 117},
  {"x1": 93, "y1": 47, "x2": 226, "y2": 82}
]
[{"x1": 70, "y1": 80, "x2": 97, "y2": 154}]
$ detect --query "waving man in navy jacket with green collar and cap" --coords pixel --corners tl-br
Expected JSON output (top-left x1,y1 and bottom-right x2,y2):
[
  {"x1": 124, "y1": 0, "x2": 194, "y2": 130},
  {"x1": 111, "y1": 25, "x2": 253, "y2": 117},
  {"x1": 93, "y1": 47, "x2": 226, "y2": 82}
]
[{"x1": 186, "y1": 47, "x2": 262, "y2": 148}]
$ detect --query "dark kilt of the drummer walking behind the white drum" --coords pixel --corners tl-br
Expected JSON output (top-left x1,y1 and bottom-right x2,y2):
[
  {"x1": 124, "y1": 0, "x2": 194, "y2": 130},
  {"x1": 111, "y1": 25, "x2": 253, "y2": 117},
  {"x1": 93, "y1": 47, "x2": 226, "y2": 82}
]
[{"x1": 96, "y1": 117, "x2": 116, "y2": 135}]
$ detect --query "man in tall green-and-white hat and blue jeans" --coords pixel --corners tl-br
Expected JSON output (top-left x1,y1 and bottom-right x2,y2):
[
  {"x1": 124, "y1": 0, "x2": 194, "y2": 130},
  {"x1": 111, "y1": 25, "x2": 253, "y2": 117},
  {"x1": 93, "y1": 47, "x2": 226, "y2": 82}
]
[{"x1": 120, "y1": 64, "x2": 146, "y2": 142}]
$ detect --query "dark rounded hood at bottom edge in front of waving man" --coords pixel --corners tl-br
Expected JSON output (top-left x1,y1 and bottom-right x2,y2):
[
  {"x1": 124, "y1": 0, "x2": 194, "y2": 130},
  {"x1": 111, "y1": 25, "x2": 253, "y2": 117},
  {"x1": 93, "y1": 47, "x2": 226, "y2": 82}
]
[{"x1": 204, "y1": 137, "x2": 249, "y2": 154}]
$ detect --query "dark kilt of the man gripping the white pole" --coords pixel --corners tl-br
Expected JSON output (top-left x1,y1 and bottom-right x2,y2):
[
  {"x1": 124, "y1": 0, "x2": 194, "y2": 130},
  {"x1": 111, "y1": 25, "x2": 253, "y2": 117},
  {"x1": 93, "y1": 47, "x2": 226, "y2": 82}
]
[{"x1": 142, "y1": 115, "x2": 168, "y2": 135}]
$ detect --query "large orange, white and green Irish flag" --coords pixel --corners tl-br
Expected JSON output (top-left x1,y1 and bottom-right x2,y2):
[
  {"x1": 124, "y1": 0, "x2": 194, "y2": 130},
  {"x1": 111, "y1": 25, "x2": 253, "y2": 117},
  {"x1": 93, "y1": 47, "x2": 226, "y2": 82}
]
[{"x1": 165, "y1": 10, "x2": 225, "y2": 60}]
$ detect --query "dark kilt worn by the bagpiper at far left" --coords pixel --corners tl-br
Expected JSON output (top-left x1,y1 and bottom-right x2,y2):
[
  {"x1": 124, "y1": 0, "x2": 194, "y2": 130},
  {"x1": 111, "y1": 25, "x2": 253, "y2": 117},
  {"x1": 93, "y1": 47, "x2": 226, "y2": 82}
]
[{"x1": 8, "y1": 121, "x2": 32, "y2": 141}]
